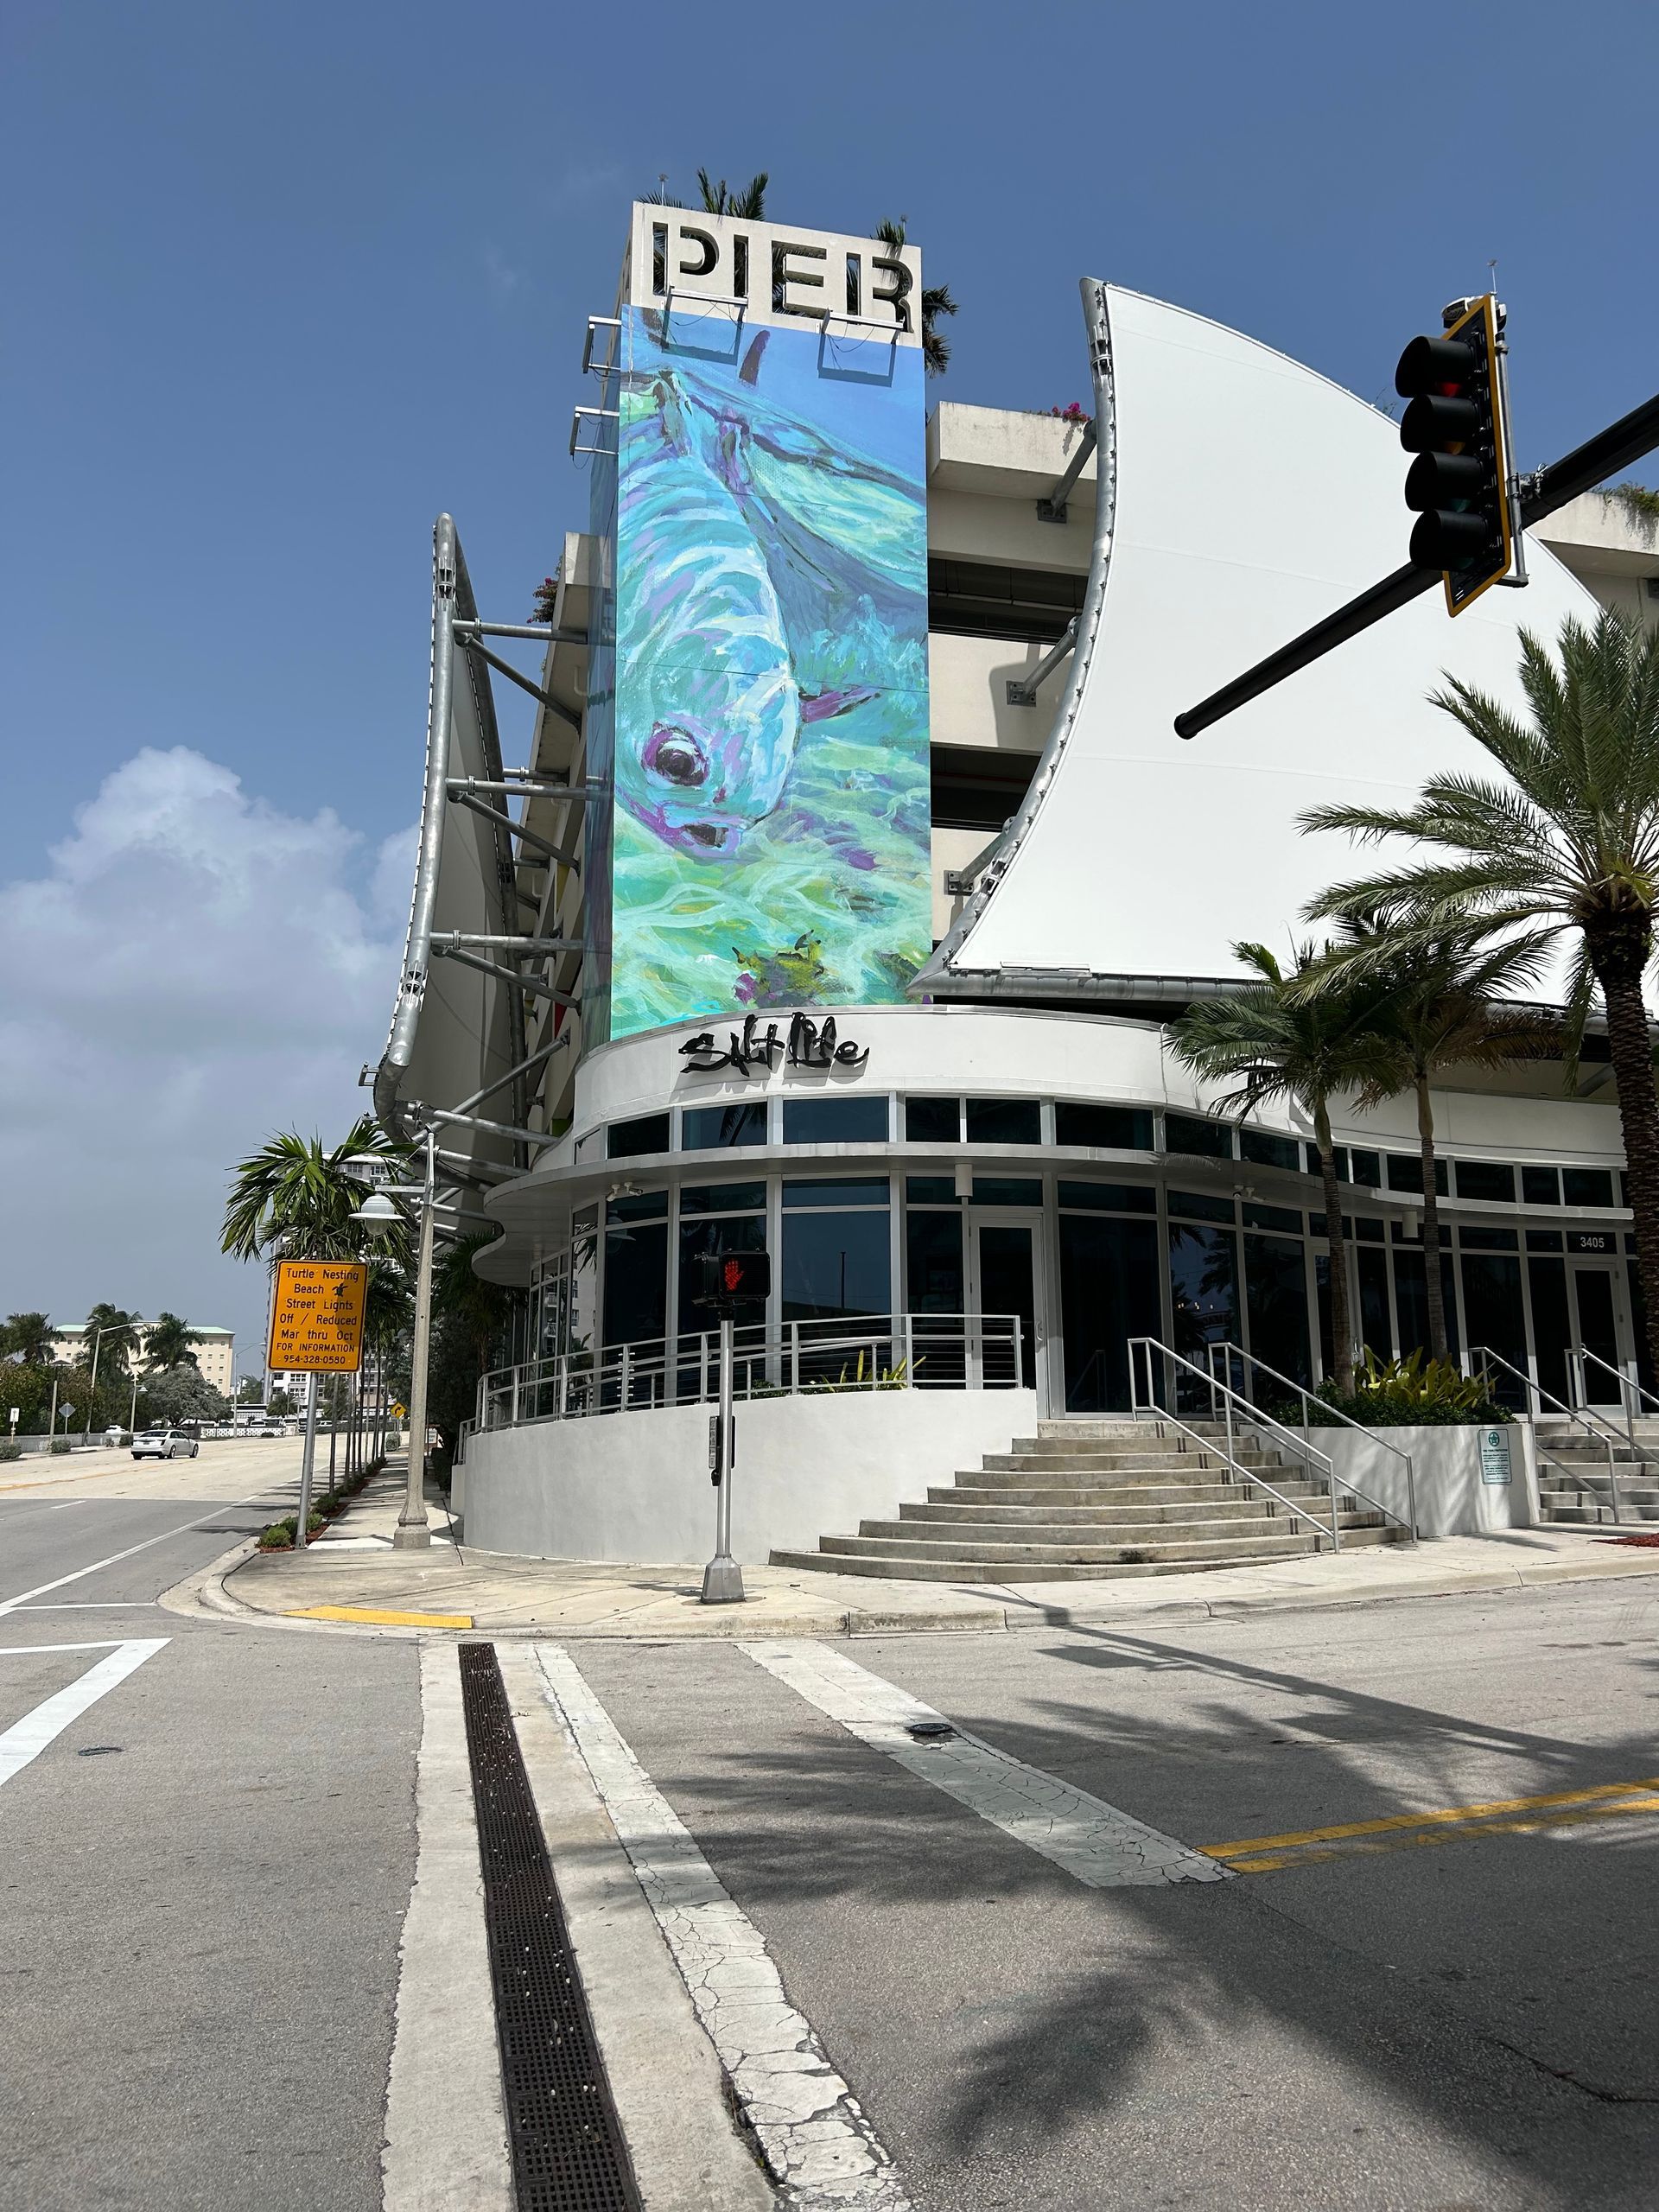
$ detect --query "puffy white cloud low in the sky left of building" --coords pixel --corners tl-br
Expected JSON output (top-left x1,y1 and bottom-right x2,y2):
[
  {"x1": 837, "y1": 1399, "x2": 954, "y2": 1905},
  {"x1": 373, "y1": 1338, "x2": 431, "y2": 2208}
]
[{"x1": 0, "y1": 746, "x2": 414, "y2": 1365}]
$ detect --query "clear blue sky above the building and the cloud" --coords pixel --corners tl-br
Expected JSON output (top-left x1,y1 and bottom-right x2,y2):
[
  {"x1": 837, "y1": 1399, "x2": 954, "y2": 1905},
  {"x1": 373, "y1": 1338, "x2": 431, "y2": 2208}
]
[{"x1": 0, "y1": 0, "x2": 1659, "y2": 1353}]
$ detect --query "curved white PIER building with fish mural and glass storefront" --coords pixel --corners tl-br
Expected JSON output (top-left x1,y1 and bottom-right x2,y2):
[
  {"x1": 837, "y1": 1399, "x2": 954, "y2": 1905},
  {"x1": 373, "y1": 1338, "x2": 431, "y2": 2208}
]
[{"x1": 376, "y1": 206, "x2": 1659, "y2": 1560}]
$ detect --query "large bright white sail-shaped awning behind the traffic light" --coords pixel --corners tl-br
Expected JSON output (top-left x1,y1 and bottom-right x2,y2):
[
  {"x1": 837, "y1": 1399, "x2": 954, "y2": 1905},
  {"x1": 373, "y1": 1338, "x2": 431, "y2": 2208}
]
[{"x1": 918, "y1": 283, "x2": 1599, "y2": 995}]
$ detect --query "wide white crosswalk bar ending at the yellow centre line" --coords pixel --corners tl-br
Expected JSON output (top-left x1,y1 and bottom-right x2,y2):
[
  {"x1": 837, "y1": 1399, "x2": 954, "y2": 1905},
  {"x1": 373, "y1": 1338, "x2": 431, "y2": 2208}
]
[{"x1": 739, "y1": 1643, "x2": 1228, "y2": 1889}]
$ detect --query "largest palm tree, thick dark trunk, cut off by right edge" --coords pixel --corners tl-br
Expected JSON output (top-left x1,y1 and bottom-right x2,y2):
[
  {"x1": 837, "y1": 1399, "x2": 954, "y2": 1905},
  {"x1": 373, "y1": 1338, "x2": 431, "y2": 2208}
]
[{"x1": 1300, "y1": 613, "x2": 1659, "y2": 1360}]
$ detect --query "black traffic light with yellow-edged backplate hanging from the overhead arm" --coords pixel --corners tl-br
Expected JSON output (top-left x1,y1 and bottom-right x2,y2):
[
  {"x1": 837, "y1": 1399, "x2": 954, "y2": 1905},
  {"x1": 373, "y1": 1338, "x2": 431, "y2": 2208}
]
[{"x1": 1394, "y1": 294, "x2": 1513, "y2": 615}]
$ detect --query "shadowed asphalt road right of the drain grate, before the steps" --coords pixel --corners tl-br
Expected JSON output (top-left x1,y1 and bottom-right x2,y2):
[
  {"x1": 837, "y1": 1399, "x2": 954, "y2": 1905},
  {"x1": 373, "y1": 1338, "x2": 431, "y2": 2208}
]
[{"x1": 570, "y1": 1581, "x2": 1659, "y2": 2212}]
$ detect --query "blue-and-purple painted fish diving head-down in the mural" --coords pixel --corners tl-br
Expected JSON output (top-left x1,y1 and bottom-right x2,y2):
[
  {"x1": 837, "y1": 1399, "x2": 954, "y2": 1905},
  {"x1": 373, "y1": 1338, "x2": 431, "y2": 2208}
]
[{"x1": 617, "y1": 338, "x2": 898, "y2": 861}]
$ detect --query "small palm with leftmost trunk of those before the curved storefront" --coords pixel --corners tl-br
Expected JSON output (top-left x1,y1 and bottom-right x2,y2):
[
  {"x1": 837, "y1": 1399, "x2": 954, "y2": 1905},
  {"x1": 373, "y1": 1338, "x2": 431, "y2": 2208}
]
[{"x1": 1173, "y1": 944, "x2": 1391, "y2": 1391}]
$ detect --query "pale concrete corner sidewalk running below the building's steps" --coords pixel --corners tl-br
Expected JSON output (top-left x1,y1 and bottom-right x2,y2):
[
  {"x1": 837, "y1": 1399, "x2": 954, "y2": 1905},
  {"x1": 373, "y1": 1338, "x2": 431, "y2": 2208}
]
[{"x1": 163, "y1": 1471, "x2": 1659, "y2": 1639}]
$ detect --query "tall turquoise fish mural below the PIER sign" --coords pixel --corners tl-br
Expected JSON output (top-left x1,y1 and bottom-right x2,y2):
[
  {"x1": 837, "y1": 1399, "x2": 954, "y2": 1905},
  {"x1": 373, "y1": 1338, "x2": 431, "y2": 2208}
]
[{"x1": 608, "y1": 308, "x2": 931, "y2": 1035}]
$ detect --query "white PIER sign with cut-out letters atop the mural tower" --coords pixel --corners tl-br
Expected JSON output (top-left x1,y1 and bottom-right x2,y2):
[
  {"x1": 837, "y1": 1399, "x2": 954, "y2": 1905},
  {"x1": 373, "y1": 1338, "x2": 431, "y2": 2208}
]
[{"x1": 624, "y1": 199, "x2": 923, "y2": 345}]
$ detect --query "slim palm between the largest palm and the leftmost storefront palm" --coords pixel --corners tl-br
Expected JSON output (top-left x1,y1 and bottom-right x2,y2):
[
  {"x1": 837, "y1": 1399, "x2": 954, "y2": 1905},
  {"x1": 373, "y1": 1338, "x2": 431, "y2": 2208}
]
[{"x1": 1296, "y1": 912, "x2": 1561, "y2": 1360}]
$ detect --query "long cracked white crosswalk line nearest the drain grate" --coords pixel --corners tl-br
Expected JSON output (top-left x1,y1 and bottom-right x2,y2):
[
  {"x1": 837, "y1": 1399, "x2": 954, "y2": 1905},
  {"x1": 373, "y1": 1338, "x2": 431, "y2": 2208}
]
[{"x1": 536, "y1": 1643, "x2": 909, "y2": 2212}]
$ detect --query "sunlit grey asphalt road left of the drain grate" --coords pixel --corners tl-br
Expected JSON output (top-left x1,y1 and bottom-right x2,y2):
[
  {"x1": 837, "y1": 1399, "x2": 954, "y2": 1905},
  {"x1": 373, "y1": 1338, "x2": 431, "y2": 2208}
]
[{"x1": 0, "y1": 1440, "x2": 420, "y2": 2212}]
